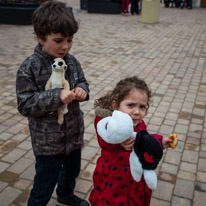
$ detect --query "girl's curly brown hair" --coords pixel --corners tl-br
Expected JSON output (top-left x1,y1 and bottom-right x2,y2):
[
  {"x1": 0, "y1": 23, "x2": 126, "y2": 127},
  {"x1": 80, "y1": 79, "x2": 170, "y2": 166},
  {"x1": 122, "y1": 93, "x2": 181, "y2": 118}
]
[{"x1": 94, "y1": 76, "x2": 152, "y2": 111}]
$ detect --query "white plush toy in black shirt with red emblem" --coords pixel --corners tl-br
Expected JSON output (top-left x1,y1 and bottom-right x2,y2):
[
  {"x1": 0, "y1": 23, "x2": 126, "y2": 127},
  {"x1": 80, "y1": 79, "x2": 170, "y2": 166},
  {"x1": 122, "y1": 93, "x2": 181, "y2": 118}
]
[{"x1": 97, "y1": 110, "x2": 163, "y2": 190}]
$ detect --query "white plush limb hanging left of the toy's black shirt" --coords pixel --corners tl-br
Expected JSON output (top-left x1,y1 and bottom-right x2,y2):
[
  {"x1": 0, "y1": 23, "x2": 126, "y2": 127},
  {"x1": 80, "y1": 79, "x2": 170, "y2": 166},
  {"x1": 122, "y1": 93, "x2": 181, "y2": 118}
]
[{"x1": 129, "y1": 150, "x2": 142, "y2": 182}]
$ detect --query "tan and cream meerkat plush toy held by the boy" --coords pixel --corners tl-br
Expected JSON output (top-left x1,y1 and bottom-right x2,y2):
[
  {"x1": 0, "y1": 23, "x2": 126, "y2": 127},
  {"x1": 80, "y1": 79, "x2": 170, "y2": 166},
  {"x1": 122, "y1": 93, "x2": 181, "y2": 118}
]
[{"x1": 45, "y1": 58, "x2": 70, "y2": 124}]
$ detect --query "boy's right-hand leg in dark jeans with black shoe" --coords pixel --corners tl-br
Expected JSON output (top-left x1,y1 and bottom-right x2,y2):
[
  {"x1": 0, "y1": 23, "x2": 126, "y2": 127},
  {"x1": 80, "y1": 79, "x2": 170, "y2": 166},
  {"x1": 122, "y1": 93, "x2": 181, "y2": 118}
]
[{"x1": 56, "y1": 149, "x2": 89, "y2": 206}]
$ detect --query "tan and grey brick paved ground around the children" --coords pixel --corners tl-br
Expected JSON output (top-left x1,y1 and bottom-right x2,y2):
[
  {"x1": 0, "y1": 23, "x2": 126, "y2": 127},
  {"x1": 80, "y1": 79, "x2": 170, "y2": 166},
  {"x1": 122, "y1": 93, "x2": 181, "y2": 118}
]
[{"x1": 0, "y1": 0, "x2": 206, "y2": 206}]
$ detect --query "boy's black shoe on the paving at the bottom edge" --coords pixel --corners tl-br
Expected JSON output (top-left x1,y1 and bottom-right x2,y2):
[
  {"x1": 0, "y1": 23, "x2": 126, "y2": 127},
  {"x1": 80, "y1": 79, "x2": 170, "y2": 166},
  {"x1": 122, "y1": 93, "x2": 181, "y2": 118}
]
[{"x1": 56, "y1": 195, "x2": 89, "y2": 206}]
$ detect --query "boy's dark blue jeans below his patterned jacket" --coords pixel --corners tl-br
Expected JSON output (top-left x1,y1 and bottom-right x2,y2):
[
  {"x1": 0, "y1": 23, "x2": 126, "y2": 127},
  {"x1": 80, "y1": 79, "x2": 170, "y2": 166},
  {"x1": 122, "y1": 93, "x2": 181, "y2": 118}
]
[{"x1": 28, "y1": 149, "x2": 81, "y2": 206}]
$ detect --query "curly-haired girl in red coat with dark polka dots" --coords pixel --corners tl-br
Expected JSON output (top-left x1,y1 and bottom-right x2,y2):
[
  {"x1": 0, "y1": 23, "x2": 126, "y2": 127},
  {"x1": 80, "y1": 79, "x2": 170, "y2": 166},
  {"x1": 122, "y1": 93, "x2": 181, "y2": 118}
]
[{"x1": 89, "y1": 76, "x2": 172, "y2": 206}]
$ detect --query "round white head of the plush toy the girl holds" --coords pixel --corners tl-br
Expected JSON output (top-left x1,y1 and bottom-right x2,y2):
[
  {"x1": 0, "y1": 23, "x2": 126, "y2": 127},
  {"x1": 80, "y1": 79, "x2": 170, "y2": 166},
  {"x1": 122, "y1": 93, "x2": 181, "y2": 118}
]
[{"x1": 97, "y1": 110, "x2": 134, "y2": 144}]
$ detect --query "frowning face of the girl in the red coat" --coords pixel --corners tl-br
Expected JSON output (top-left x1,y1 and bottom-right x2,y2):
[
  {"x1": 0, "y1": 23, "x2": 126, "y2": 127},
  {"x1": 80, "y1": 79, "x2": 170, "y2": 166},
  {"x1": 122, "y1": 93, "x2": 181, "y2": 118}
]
[{"x1": 115, "y1": 88, "x2": 148, "y2": 126}]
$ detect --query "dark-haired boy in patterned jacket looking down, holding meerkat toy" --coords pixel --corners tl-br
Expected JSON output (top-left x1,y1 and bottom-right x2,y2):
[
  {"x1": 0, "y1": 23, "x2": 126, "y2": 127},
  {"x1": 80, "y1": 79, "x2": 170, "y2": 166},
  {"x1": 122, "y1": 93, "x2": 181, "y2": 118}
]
[{"x1": 16, "y1": 1, "x2": 89, "y2": 206}]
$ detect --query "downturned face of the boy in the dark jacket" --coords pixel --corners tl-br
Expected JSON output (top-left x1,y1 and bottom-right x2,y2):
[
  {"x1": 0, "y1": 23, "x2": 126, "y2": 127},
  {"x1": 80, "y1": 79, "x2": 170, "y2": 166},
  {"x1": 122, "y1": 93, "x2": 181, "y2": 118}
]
[{"x1": 37, "y1": 33, "x2": 72, "y2": 58}]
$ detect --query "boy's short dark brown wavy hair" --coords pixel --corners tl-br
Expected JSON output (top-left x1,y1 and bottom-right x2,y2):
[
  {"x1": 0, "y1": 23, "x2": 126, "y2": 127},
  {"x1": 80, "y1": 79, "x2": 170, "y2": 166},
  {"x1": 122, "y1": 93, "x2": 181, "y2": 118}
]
[{"x1": 32, "y1": 1, "x2": 79, "y2": 40}]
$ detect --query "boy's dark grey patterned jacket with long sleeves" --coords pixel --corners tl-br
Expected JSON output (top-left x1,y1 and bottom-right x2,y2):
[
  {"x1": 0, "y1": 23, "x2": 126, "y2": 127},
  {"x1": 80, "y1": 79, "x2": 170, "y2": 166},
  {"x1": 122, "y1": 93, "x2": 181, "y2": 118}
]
[{"x1": 16, "y1": 44, "x2": 89, "y2": 155}]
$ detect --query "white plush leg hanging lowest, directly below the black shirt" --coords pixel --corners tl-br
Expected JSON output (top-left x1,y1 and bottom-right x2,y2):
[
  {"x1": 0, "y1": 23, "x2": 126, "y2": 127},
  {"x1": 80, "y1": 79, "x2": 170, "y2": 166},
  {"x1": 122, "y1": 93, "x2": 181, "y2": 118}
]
[{"x1": 144, "y1": 170, "x2": 157, "y2": 190}]
